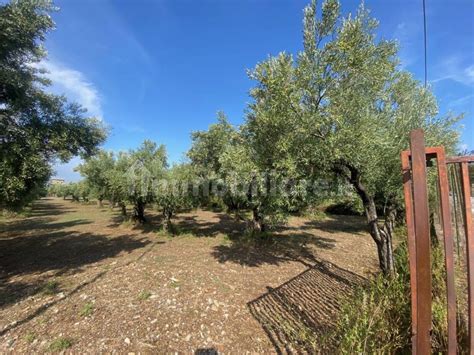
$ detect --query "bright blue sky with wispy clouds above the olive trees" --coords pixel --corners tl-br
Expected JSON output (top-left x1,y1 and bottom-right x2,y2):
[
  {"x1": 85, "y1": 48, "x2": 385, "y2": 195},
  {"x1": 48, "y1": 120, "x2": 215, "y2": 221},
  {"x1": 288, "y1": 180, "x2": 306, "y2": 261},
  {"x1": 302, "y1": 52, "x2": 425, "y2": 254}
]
[{"x1": 44, "y1": 0, "x2": 474, "y2": 181}]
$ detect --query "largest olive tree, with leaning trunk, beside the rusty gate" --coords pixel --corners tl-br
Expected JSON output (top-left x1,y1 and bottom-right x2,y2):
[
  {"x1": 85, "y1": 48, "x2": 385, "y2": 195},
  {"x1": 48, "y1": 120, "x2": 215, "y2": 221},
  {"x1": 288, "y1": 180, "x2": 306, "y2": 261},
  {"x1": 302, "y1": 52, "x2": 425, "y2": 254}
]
[{"x1": 246, "y1": 0, "x2": 458, "y2": 274}]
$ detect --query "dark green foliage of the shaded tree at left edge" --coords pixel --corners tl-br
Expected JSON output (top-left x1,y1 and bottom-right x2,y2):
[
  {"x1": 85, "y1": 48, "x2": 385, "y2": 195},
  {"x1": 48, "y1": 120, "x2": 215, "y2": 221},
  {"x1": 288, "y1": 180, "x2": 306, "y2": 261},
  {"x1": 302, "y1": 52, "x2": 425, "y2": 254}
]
[{"x1": 0, "y1": 0, "x2": 105, "y2": 209}]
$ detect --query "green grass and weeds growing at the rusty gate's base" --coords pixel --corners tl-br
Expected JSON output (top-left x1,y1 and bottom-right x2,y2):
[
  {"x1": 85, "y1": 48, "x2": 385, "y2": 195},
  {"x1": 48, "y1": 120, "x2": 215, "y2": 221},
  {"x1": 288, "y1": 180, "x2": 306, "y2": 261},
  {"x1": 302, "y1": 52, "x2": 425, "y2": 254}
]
[{"x1": 330, "y1": 244, "x2": 465, "y2": 354}]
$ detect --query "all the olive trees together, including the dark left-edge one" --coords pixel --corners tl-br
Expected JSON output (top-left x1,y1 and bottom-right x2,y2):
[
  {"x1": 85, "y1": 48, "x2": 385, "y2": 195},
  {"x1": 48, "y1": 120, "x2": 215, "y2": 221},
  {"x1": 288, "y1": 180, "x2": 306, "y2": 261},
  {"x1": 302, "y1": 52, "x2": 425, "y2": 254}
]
[{"x1": 4, "y1": 0, "x2": 459, "y2": 273}]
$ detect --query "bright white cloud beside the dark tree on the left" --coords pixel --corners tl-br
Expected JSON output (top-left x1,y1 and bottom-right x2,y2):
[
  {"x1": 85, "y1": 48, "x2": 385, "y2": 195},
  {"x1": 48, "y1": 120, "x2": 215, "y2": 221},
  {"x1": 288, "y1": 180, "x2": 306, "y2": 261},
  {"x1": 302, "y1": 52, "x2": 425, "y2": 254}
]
[{"x1": 34, "y1": 60, "x2": 103, "y2": 119}]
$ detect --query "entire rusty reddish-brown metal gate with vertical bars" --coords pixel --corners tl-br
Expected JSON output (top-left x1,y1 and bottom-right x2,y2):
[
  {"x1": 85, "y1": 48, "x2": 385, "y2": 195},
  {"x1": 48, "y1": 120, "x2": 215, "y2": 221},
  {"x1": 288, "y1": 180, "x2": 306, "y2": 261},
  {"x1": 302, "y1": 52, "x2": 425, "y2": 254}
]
[{"x1": 401, "y1": 130, "x2": 474, "y2": 354}]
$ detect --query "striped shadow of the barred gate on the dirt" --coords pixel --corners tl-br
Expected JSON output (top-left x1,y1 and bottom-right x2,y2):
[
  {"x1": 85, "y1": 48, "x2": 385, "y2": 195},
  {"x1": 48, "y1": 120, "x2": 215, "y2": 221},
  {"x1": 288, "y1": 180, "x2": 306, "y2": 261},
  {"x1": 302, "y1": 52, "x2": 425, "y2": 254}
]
[{"x1": 247, "y1": 261, "x2": 366, "y2": 354}]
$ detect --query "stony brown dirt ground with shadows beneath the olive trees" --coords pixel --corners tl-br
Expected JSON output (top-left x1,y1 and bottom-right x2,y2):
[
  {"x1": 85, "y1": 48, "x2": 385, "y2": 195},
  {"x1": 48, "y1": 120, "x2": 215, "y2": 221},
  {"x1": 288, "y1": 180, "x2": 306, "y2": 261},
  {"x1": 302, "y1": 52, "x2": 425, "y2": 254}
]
[{"x1": 0, "y1": 198, "x2": 376, "y2": 354}]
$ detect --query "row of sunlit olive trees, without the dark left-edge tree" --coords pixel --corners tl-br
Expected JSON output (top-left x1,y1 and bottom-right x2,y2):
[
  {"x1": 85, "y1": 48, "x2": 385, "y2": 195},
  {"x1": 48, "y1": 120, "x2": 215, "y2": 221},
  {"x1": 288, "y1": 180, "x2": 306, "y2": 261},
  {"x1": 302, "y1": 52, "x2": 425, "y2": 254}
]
[{"x1": 58, "y1": 0, "x2": 460, "y2": 274}]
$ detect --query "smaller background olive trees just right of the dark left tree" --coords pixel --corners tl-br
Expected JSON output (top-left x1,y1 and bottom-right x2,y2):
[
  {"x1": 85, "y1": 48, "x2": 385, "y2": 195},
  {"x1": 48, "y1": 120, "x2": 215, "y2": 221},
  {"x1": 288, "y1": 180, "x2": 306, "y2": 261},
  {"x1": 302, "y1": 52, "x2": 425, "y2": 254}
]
[{"x1": 50, "y1": 140, "x2": 197, "y2": 229}]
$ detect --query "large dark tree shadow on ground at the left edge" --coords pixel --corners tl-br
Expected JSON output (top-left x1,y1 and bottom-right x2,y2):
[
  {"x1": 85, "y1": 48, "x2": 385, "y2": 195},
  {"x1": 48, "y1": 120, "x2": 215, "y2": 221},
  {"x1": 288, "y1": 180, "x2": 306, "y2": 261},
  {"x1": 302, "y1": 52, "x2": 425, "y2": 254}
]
[{"x1": 0, "y1": 231, "x2": 150, "y2": 308}]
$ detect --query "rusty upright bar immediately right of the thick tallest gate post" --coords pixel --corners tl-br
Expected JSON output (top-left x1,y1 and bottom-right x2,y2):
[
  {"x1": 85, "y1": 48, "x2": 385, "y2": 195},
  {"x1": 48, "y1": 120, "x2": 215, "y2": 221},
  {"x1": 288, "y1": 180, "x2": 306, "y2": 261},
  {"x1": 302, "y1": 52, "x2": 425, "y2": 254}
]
[{"x1": 437, "y1": 147, "x2": 456, "y2": 354}]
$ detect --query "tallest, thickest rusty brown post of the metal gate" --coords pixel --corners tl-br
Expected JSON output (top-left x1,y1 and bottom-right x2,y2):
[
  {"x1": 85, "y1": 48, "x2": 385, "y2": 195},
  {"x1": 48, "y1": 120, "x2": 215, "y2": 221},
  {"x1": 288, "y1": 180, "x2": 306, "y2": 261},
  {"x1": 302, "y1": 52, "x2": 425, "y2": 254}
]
[{"x1": 410, "y1": 129, "x2": 431, "y2": 355}]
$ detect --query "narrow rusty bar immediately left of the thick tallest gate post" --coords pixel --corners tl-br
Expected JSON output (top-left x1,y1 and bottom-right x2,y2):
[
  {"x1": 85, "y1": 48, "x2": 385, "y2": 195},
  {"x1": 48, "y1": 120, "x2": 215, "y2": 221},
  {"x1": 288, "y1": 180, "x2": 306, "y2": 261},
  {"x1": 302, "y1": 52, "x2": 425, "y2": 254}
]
[{"x1": 401, "y1": 150, "x2": 416, "y2": 353}]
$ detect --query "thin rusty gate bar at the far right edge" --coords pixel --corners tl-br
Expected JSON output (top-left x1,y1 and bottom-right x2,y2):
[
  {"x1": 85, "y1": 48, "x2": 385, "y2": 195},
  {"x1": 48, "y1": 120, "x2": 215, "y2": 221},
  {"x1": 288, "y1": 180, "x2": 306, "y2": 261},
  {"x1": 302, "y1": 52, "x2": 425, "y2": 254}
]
[{"x1": 461, "y1": 161, "x2": 474, "y2": 354}]
